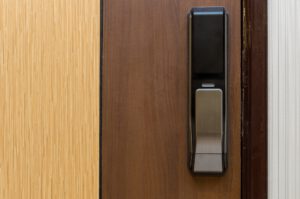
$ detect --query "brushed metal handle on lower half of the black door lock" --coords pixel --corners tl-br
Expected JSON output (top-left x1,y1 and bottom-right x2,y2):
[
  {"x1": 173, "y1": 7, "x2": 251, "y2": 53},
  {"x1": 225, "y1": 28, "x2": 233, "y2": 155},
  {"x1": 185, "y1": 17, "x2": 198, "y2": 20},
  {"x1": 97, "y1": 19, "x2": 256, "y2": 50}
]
[{"x1": 194, "y1": 89, "x2": 223, "y2": 173}]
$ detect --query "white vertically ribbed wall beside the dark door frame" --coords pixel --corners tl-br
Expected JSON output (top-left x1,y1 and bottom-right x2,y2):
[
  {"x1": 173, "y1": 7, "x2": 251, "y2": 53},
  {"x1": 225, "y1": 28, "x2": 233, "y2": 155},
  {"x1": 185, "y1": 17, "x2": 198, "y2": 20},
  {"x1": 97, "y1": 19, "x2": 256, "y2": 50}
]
[{"x1": 268, "y1": 0, "x2": 300, "y2": 199}]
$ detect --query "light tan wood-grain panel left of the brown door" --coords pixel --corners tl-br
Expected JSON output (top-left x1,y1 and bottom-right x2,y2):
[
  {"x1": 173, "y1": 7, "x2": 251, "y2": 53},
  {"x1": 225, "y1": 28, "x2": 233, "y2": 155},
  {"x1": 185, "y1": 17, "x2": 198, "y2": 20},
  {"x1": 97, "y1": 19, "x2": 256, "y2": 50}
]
[{"x1": 0, "y1": 0, "x2": 100, "y2": 199}]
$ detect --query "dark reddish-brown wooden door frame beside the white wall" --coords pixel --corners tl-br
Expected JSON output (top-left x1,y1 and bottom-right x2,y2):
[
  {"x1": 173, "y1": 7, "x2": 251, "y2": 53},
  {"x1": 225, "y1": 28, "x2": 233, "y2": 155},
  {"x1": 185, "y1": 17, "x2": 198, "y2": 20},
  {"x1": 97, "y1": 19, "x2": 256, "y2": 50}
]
[{"x1": 242, "y1": 0, "x2": 268, "y2": 199}]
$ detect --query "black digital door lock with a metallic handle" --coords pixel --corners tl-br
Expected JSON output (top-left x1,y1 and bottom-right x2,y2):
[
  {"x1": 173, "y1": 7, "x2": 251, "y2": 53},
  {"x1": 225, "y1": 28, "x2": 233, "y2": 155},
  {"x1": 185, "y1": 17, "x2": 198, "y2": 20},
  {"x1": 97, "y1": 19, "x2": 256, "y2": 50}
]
[{"x1": 189, "y1": 7, "x2": 228, "y2": 174}]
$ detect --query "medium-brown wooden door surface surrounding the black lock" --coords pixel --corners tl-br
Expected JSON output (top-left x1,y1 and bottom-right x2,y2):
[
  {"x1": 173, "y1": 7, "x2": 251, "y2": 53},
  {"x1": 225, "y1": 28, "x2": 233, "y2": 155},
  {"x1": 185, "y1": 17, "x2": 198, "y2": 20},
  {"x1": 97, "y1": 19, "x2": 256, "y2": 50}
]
[{"x1": 102, "y1": 0, "x2": 241, "y2": 199}]
